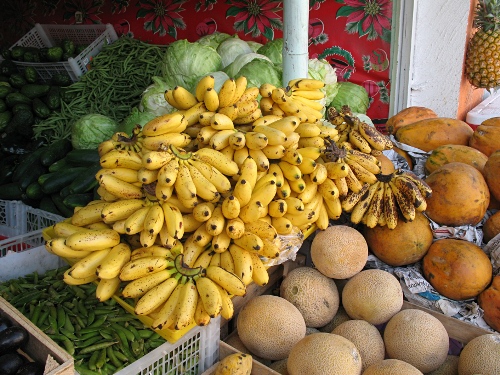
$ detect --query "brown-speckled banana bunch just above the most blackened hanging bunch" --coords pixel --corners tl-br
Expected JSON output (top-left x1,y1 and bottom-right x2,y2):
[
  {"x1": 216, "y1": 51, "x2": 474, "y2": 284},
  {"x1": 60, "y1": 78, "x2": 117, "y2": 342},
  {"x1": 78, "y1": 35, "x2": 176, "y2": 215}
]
[{"x1": 326, "y1": 106, "x2": 393, "y2": 155}]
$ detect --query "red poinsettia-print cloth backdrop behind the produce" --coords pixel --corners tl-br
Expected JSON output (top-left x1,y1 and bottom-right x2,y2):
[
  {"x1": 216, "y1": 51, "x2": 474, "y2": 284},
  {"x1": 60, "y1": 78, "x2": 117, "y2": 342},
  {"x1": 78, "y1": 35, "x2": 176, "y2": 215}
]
[{"x1": 0, "y1": 0, "x2": 392, "y2": 124}]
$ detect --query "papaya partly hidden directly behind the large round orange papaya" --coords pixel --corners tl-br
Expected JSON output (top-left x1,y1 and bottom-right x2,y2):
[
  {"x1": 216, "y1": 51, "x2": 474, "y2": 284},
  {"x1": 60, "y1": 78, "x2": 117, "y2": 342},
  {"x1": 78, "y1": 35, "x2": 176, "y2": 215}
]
[{"x1": 424, "y1": 145, "x2": 488, "y2": 175}]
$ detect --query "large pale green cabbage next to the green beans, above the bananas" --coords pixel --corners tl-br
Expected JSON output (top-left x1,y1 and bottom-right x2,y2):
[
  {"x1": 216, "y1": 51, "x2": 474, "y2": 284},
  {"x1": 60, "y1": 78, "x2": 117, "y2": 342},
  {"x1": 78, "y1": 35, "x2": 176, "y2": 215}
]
[{"x1": 162, "y1": 39, "x2": 222, "y2": 92}]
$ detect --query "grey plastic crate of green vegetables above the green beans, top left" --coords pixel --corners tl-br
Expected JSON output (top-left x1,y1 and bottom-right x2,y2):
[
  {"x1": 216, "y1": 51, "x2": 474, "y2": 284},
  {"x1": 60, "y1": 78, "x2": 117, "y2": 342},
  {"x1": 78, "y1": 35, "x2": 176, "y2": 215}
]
[{"x1": 11, "y1": 23, "x2": 118, "y2": 82}]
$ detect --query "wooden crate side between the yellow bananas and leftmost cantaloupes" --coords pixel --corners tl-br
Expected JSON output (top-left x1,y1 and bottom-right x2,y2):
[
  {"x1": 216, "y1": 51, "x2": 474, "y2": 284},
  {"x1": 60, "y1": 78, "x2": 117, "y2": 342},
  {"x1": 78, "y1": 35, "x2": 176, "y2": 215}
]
[{"x1": 221, "y1": 254, "x2": 305, "y2": 340}]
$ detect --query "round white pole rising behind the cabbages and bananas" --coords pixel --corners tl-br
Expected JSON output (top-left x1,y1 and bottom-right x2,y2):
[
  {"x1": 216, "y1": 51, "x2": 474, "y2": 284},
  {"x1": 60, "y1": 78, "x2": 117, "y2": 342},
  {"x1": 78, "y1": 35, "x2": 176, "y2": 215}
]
[{"x1": 283, "y1": 0, "x2": 309, "y2": 86}]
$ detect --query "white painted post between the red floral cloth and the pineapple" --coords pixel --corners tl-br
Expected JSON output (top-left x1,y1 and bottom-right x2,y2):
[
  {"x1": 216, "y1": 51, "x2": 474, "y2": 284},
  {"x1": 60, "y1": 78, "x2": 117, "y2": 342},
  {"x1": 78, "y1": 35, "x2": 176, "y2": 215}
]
[{"x1": 390, "y1": 0, "x2": 470, "y2": 117}]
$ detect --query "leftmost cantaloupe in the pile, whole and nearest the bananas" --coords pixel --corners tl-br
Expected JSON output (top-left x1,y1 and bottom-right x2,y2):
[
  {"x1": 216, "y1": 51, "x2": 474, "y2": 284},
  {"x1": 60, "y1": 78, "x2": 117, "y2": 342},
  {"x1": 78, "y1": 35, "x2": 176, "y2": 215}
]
[{"x1": 237, "y1": 295, "x2": 306, "y2": 360}]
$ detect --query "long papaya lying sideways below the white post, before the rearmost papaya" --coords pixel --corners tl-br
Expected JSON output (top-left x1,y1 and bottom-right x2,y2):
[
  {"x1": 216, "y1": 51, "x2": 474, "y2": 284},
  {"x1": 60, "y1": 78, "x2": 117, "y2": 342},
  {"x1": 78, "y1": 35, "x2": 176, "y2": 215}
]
[{"x1": 395, "y1": 117, "x2": 474, "y2": 152}]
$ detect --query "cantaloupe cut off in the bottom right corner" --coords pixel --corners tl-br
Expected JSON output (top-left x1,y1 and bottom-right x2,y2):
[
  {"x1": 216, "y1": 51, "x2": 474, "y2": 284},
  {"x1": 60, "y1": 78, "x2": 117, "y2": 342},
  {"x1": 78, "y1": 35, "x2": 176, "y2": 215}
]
[{"x1": 458, "y1": 333, "x2": 500, "y2": 375}]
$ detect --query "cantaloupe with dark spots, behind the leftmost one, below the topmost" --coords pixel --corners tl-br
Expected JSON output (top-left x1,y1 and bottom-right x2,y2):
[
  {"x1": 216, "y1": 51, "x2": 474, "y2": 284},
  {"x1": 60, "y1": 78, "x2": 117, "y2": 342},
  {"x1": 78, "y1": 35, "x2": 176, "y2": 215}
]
[{"x1": 280, "y1": 267, "x2": 339, "y2": 327}]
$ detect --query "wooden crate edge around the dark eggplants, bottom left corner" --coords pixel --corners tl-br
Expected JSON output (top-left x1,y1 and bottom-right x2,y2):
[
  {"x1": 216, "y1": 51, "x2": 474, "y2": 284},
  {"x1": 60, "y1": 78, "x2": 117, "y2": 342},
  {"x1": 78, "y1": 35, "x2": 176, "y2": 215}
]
[{"x1": 0, "y1": 297, "x2": 75, "y2": 375}]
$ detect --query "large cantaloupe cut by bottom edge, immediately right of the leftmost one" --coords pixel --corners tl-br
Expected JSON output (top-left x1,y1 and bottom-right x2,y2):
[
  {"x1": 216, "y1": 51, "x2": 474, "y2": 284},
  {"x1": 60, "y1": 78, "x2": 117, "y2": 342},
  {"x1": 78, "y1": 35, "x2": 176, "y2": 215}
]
[{"x1": 287, "y1": 332, "x2": 362, "y2": 375}]
